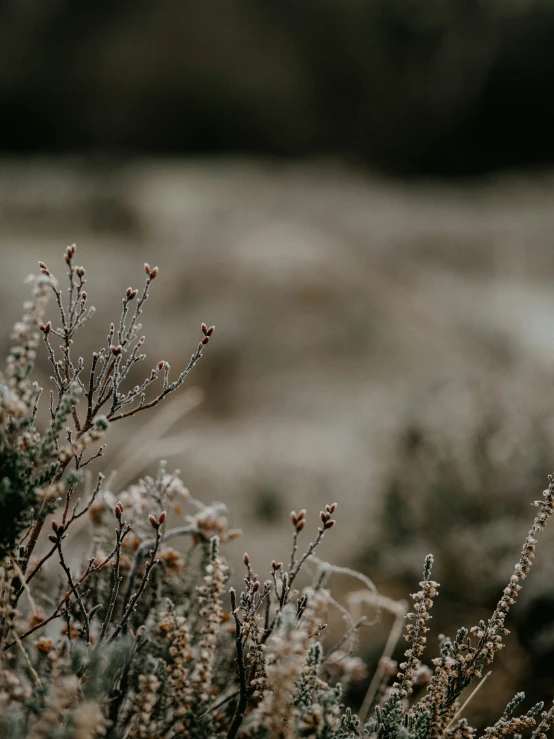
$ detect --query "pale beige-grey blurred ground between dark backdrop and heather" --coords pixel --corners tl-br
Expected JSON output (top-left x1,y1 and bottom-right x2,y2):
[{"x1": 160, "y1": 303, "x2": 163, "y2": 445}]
[{"x1": 0, "y1": 160, "x2": 554, "y2": 720}]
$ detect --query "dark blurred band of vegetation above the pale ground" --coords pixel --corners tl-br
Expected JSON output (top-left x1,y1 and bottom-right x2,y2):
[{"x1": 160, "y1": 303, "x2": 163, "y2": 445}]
[{"x1": 0, "y1": 0, "x2": 554, "y2": 175}]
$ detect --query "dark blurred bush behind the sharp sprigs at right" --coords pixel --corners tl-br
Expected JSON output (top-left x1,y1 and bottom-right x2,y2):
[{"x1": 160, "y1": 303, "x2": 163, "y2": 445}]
[{"x1": 355, "y1": 383, "x2": 554, "y2": 724}]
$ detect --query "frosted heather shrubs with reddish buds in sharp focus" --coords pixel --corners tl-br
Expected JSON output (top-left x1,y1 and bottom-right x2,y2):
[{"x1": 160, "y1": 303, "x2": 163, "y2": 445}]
[{"x1": 0, "y1": 246, "x2": 554, "y2": 739}]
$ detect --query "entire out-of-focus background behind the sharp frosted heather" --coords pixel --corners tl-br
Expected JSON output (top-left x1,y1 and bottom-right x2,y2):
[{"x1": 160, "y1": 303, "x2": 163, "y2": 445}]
[{"x1": 0, "y1": 0, "x2": 554, "y2": 726}]
